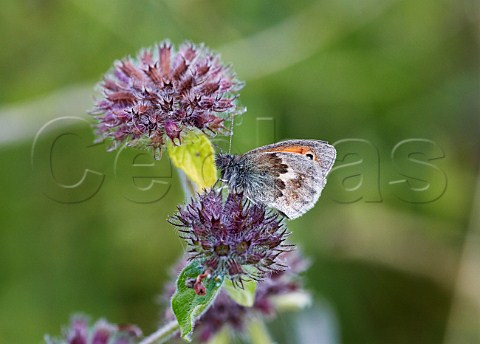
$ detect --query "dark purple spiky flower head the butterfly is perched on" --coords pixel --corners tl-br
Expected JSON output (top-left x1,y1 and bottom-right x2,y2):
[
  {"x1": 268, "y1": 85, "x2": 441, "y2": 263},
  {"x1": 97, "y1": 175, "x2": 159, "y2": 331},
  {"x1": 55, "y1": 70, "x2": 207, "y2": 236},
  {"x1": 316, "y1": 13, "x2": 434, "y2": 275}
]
[{"x1": 170, "y1": 189, "x2": 292, "y2": 285}]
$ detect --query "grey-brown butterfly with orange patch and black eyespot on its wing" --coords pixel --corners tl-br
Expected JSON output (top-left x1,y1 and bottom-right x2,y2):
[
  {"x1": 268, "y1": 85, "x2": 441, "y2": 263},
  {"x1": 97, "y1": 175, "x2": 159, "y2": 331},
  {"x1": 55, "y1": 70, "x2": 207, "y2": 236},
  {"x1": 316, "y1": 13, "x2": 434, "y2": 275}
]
[{"x1": 215, "y1": 140, "x2": 336, "y2": 219}]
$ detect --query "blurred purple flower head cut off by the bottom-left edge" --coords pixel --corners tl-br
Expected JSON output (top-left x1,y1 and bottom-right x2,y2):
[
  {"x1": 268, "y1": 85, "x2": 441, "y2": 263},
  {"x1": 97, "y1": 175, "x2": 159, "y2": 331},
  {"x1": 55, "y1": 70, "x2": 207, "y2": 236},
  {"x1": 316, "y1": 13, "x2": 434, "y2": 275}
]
[{"x1": 45, "y1": 315, "x2": 142, "y2": 344}]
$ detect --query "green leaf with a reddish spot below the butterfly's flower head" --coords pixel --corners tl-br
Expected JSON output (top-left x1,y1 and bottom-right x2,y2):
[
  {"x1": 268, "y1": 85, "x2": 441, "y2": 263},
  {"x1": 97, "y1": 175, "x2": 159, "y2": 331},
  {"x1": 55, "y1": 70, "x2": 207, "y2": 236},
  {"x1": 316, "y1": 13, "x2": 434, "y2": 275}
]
[{"x1": 172, "y1": 261, "x2": 223, "y2": 341}]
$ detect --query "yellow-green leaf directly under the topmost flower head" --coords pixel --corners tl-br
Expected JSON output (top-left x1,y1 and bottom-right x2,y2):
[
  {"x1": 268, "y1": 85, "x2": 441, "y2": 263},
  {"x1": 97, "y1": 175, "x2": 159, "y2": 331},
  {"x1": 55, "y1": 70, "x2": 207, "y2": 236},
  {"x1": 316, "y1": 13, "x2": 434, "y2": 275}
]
[{"x1": 167, "y1": 131, "x2": 217, "y2": 190}]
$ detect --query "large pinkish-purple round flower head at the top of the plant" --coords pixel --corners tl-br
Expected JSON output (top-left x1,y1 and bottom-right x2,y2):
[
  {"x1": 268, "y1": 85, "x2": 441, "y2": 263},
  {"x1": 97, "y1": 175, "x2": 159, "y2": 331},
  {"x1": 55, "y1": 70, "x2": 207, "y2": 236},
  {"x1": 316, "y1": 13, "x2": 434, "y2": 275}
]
[{"x1": 93, "y1": 41, "x2": 244, "y2": 156}]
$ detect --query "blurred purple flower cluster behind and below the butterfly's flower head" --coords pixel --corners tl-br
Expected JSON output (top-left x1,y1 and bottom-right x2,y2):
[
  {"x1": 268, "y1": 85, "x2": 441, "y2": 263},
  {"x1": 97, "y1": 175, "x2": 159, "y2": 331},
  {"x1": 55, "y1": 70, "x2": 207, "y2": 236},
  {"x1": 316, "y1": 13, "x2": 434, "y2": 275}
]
[{"x1": 162, "y1": 250, "x2": 309, "y2": 343}]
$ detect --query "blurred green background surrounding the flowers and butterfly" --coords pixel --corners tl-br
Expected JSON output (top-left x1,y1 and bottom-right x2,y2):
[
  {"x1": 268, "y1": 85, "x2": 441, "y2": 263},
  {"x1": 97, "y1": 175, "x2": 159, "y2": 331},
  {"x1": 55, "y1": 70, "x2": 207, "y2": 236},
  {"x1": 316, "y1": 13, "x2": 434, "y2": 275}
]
[{"x1": 0, "y1": 0, "x2": 480, "y2": 344}]
